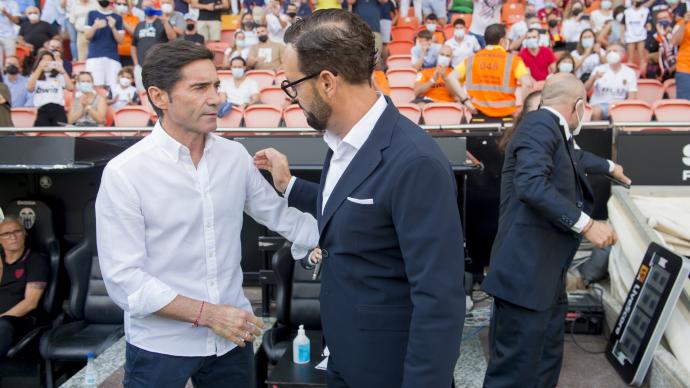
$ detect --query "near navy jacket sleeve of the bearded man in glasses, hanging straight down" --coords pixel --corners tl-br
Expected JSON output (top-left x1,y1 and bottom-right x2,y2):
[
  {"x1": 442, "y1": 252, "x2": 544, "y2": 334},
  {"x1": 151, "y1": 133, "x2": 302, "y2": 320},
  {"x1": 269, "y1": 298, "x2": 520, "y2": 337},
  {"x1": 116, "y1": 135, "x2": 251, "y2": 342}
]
[{"x1": 391, "y1": 156, "x2": 465, "y2": 388}]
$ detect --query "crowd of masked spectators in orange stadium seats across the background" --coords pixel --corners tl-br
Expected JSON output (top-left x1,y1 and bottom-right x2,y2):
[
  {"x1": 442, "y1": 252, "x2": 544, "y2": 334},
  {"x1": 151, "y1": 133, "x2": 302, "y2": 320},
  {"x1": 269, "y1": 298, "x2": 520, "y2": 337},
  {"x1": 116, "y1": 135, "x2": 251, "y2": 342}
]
[{"x1": 0, "y1": 0, "x2": 690, "y2": 127}]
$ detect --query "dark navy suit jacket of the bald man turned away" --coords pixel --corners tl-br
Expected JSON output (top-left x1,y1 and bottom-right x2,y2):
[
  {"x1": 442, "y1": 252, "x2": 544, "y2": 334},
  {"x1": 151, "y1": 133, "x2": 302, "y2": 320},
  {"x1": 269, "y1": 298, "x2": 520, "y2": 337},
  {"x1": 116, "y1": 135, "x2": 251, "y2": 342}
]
[{"x1": 482, "y1": 109, "x2": 609, "y2": 311}]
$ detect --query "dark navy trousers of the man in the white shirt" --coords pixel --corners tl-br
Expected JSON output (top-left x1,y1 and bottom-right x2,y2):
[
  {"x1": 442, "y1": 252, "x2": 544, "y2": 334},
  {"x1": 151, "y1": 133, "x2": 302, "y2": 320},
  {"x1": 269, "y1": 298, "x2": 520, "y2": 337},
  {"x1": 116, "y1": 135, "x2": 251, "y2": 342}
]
[{"x1": 122, "y1": 343, "x2": 255, "y2": 388}]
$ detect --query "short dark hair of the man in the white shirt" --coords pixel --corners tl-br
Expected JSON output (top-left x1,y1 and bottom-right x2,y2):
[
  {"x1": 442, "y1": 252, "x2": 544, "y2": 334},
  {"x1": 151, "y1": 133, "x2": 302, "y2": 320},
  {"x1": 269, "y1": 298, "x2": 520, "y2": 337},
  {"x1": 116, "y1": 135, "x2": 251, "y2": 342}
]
[{"x1": 141, "y1": 39, "x2": 213, "y2": 117}]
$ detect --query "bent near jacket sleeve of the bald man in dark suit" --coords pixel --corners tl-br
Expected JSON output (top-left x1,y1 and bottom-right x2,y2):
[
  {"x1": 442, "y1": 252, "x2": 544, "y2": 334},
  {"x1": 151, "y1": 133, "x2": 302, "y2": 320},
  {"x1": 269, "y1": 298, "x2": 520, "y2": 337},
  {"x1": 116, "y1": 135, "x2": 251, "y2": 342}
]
[{"x1": 511, "y1": 114, "x2": 581, "y2": 231}]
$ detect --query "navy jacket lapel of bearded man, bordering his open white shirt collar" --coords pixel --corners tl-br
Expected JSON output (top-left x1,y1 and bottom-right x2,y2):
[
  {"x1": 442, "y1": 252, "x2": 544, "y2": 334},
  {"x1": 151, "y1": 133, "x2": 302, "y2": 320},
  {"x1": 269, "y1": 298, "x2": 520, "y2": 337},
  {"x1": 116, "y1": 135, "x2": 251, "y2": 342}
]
[{"x1": 317, "y1": 97, "x2": 400, "y2": 233}]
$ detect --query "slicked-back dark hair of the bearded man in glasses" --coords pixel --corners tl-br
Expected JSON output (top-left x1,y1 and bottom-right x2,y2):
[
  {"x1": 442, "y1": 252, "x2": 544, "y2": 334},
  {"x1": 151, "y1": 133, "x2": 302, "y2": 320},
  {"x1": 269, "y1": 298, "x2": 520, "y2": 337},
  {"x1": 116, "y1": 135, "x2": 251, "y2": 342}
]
[{"x1": 284, "y1": 9, "x2": 376, "y2": 84}]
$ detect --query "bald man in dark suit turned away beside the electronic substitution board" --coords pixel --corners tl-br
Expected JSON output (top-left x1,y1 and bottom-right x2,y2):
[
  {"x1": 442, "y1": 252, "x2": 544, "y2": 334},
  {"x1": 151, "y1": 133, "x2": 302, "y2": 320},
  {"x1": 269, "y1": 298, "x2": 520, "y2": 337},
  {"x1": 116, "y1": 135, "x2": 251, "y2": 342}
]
[{"x1": 482, "y1": 74, "x2": 630, "y2": 388}]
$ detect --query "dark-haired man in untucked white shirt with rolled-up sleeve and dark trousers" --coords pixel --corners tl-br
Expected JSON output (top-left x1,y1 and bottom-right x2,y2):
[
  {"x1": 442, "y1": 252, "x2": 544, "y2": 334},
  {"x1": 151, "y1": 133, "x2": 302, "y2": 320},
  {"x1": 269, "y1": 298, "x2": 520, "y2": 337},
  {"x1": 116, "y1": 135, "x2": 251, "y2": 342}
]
[{"x1": 96, "y1": 40, "x2": 318, "y2": 388}]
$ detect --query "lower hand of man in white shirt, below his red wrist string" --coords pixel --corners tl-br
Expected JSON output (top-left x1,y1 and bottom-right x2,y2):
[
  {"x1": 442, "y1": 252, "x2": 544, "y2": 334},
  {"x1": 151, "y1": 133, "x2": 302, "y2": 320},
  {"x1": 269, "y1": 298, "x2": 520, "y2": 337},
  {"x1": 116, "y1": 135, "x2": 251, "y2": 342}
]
[{"x1": 199, "y1": 304, "x2": 264, "y2": 347}]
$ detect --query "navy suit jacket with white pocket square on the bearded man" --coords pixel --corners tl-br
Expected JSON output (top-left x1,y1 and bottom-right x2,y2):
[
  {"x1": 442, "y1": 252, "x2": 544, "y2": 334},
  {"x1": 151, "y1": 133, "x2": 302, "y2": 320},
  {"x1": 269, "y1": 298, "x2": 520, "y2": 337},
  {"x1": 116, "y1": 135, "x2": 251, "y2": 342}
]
[{"x1": 288, "y1": 100, "x2": 465, "y2": 388}]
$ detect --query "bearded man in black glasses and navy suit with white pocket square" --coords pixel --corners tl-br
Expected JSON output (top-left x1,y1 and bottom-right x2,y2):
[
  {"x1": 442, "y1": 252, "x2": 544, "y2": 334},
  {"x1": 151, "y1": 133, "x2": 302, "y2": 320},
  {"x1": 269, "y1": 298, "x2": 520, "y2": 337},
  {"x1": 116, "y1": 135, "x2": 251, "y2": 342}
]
[{"x1": 255, "y1": 9, "x2": 465, "y2": 388}]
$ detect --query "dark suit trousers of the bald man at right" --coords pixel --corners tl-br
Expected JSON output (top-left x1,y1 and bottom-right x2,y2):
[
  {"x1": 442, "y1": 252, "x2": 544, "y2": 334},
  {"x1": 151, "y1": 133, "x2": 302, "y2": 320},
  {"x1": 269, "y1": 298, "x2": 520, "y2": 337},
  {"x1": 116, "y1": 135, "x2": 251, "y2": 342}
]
[{"x1": 484, "y1": 292, "x2": 568, "y2": 388}]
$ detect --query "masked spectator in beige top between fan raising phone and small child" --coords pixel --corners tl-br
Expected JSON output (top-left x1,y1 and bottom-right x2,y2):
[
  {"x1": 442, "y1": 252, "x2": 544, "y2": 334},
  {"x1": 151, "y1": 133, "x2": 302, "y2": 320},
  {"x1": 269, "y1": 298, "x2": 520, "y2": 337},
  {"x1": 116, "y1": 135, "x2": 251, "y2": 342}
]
[{"x1": 67, "y1": 71, "x2": 107, "y2": 127}]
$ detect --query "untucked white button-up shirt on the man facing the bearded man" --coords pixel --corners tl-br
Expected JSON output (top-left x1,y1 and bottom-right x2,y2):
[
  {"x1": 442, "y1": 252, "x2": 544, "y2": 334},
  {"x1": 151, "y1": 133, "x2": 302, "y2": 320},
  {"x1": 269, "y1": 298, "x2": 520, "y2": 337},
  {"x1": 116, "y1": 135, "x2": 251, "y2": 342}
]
[{"x1": 96, "y1": 123, "x2": 318, "y2": 356}]
